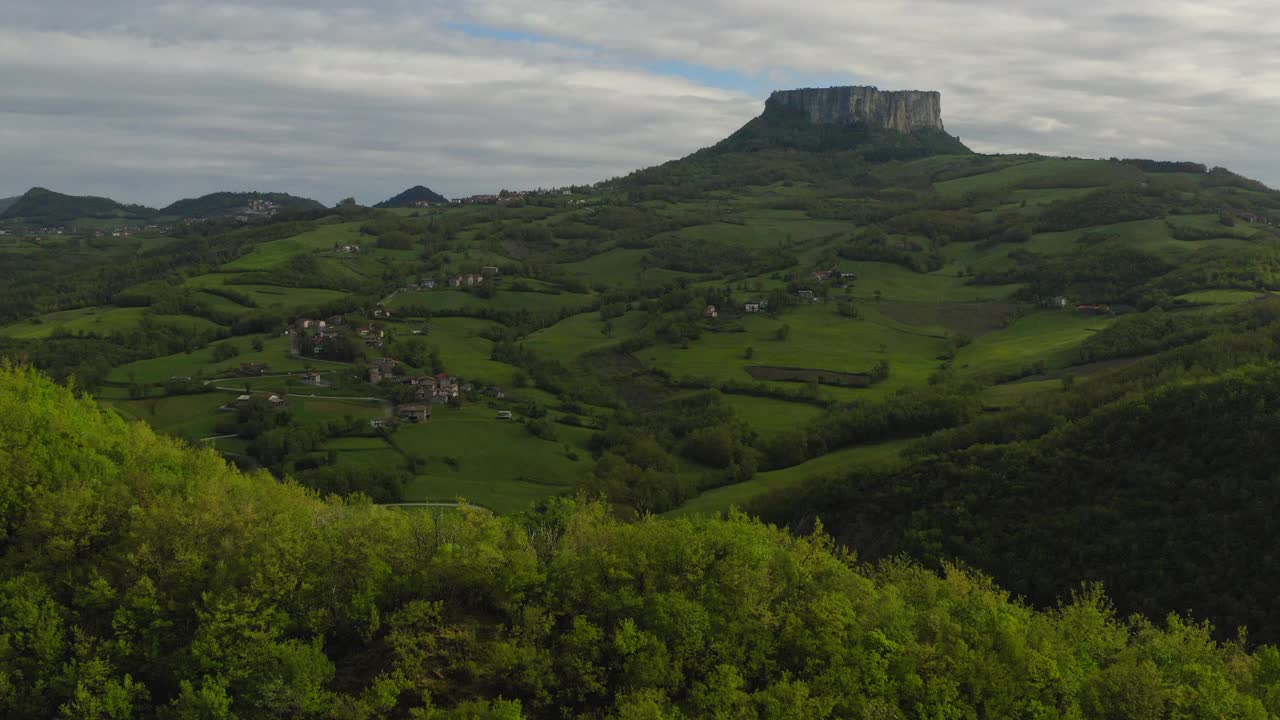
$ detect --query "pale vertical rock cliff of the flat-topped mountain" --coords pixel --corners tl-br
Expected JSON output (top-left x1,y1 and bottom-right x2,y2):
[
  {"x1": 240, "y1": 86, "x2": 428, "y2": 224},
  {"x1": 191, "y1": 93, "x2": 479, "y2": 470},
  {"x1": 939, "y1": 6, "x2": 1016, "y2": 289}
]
[{"x1": 768, "y1": 87, "x2": 945, "y2": 133}]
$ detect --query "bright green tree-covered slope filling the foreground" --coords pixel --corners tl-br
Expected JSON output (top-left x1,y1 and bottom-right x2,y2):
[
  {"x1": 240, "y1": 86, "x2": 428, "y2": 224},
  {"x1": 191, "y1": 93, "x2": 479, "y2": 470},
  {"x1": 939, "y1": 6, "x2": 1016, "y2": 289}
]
[{"x1": 0, "y1": 368, "x2": 1280, "y2": 720}]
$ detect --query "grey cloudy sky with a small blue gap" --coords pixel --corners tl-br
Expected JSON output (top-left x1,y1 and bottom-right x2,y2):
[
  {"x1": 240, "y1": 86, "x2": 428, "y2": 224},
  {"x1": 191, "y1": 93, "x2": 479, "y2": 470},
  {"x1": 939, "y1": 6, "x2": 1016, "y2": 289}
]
[{"x1": 0, "y1": 0, "x2": 1280, "y2": 205}]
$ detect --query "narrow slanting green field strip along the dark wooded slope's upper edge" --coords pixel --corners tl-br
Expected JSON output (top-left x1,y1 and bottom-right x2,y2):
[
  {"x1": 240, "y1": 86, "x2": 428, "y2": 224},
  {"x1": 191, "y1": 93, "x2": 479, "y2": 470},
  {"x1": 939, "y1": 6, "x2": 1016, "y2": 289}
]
[{"x1": 668, "y1": 439, "x2": 914, "y2": 516}]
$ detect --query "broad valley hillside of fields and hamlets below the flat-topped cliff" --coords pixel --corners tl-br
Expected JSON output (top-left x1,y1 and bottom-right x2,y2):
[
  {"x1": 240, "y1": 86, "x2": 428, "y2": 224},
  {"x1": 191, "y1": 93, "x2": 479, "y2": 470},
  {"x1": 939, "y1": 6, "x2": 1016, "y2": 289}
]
[{"x1": 12, "y1": 96, "x2": 1280, "y2": 655}]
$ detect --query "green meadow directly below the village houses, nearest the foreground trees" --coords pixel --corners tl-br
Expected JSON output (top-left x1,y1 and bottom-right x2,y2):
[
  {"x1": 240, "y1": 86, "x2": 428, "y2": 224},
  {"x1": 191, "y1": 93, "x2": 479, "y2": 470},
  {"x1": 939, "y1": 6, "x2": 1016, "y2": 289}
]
[{"x1": 394, "y1": 406, "x2": 591, "y2": 512}]
